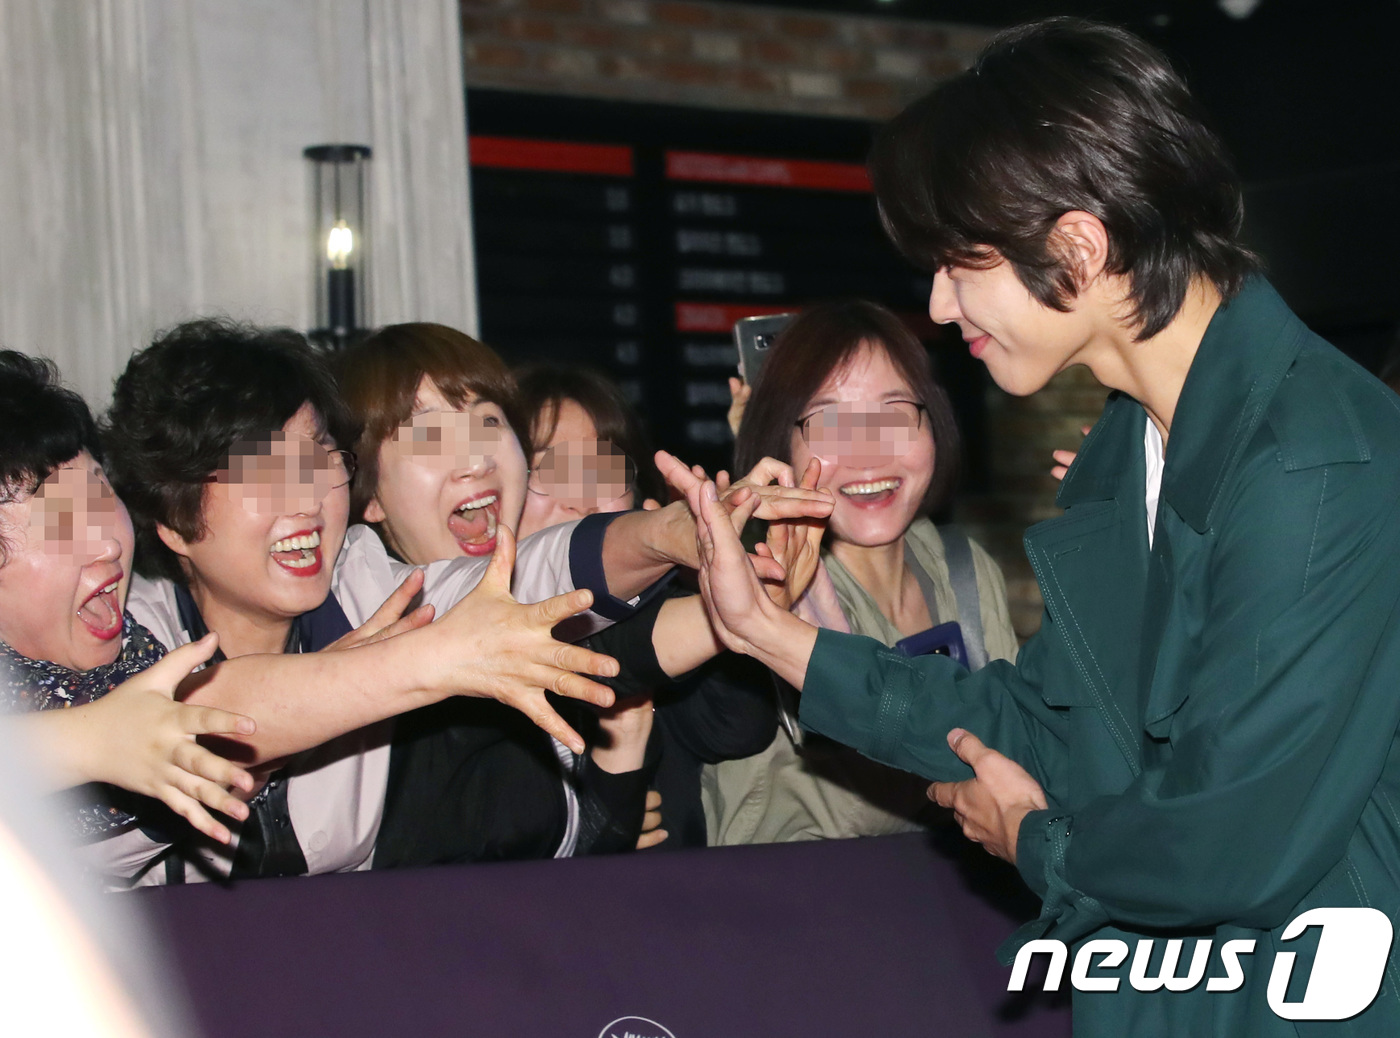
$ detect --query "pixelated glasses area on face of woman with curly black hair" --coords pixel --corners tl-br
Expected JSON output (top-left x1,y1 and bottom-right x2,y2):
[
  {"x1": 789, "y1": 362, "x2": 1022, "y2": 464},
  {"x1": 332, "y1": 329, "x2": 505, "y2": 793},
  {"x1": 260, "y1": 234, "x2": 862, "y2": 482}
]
[{"x1": 204, "y1": 430, "x2": 357, "y2": 515}]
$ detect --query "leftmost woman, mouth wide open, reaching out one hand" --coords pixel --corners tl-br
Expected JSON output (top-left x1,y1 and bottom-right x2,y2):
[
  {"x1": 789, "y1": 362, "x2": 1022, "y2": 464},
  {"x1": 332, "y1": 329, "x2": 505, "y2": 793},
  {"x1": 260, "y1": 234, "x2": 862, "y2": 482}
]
[{"x1": 0, "y1": 350, "x2": 255, "y2": 857}]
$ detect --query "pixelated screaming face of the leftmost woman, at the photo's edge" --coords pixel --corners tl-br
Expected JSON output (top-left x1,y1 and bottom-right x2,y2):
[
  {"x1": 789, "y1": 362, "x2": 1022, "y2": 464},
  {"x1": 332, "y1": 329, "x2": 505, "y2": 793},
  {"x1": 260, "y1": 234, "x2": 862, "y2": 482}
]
[{"x1": 0, "y1": 451, "x2": 134, "y2": 671}]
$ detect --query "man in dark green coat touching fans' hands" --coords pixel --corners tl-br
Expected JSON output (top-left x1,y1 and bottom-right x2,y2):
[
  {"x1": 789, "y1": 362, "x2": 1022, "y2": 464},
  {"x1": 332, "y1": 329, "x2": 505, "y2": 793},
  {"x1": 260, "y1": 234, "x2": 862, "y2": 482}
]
[{"x1": 678, "y1": 20, "x2": 1400, "y2": 1038}]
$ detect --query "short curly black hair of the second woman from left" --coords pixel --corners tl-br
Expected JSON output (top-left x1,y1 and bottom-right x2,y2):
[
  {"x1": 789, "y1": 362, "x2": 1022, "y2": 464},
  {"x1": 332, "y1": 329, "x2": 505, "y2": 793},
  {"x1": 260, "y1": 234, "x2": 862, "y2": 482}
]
[{"x1": 102, "y1": 319, "x2": 357, "y2": 583}]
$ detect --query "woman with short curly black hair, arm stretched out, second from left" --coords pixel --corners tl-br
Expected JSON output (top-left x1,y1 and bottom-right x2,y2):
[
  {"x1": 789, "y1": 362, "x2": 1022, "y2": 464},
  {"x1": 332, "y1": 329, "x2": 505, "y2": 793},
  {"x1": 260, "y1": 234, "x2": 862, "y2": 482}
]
[{"x1": 106, "y1": 321, "x2": 641, "y2": 883}]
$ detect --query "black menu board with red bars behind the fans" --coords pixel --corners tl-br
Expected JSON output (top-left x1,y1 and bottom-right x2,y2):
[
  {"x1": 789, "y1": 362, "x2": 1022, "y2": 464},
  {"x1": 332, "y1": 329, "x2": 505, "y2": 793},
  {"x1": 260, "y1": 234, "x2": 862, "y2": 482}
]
[{"x1": 469, "y1": 91, "x2": 981, "y2": 479}]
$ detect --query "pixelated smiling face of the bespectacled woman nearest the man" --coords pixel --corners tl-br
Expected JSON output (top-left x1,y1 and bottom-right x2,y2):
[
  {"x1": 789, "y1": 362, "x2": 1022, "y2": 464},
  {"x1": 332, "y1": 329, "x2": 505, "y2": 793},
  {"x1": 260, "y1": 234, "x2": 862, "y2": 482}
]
[{"x1": 792, "y1": 342, "x2": 934, "y2": 548}]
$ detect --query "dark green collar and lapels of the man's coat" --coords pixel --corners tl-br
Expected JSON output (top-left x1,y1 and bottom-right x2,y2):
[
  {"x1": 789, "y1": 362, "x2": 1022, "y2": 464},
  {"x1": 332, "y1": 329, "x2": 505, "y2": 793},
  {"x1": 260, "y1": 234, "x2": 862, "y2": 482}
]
[{"x1": 1056, "y1": 276, "x2": 1306, "y2": 532}]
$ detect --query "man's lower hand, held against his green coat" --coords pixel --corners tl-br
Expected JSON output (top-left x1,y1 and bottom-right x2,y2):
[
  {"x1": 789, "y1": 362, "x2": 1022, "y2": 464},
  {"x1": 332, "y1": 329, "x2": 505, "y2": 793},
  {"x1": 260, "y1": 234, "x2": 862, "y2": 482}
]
[{"x1": 928, "y1": 728, "x2": 1046, "y2": 864}]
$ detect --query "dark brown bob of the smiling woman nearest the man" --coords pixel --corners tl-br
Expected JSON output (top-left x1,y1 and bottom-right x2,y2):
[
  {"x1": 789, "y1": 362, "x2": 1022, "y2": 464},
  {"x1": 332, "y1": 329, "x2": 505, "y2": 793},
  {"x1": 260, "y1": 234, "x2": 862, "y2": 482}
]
[{"x1": 734, "y1": 300, "x2": 962, "y2": 513}]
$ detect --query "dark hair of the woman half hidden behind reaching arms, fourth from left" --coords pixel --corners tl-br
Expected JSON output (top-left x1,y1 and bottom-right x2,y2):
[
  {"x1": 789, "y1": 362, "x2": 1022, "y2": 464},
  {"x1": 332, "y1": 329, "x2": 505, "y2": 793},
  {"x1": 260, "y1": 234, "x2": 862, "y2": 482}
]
[{"x1": 515, "y1": 364, "x2": 665, "y2": 506}]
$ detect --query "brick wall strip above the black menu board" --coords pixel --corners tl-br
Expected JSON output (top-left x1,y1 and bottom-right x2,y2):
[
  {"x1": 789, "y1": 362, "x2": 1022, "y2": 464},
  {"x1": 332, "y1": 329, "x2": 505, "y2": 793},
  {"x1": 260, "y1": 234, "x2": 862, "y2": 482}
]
[{"x1": 462, "y1": 0, "x2": 990, "y2": 119}]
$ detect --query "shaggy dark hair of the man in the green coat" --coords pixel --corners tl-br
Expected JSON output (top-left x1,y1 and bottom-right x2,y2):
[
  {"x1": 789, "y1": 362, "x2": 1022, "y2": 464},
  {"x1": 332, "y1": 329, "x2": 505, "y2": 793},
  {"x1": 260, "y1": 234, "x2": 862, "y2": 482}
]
[{"x1": 869, "y1": 18, "x2": 1257, "y2": 339}]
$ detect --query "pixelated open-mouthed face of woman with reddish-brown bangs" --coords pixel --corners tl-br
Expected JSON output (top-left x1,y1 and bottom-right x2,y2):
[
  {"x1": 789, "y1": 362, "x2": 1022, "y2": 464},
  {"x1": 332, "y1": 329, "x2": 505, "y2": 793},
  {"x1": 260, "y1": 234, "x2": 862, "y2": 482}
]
[{"x1": 365, "y1": 377, "x2": 526, "y2": 566}]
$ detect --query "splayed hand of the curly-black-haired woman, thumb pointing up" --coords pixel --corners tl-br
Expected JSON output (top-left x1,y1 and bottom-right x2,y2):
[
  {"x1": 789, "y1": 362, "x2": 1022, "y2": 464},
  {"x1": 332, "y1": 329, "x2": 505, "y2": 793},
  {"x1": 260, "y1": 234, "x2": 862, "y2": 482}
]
[{"x1": 412, "y1": 525, "x2": 617, "y2": 754}]
